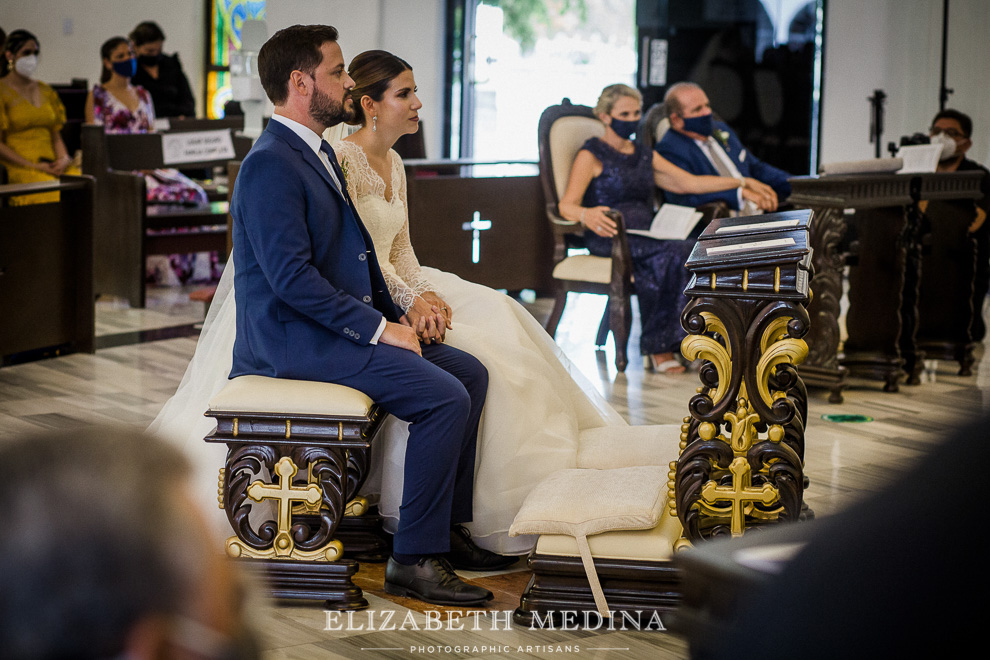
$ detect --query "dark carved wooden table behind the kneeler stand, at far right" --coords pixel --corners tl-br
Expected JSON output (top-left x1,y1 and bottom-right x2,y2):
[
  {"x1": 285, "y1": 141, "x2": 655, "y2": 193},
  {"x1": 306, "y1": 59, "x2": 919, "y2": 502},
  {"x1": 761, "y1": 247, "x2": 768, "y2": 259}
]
[{"x1": 788, "y1": 173, "x2": 980, "y2": 392}]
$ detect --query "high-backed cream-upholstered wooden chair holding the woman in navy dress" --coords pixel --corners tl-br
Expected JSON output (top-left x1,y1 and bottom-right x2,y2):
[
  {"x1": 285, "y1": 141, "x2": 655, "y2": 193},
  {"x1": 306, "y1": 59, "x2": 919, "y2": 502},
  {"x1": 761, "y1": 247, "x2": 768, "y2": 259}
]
[{"x1": 538, "y1": 99, "x2": 633, "y2": 371}]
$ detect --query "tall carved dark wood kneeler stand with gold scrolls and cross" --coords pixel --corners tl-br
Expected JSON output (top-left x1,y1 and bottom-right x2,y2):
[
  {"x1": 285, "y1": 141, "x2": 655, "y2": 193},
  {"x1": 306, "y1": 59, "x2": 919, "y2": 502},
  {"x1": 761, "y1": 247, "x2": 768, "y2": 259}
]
[{"x1": 669, "y1": 211, "x2": 814, "y2": 541}]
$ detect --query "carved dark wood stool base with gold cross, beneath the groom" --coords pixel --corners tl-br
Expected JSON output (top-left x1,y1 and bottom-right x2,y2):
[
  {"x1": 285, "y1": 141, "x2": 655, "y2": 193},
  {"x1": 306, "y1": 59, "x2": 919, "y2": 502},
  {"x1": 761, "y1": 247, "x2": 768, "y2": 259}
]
[{"x1": 206, "y1": 406, "x2": 387, "y2": 609}]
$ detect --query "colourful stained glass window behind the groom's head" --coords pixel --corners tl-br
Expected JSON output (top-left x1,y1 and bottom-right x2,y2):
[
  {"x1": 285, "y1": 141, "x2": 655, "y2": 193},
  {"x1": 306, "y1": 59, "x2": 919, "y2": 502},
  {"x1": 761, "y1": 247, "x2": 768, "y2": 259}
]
[{"x1": 206, "y1": 0, "x2": 266, "y2": 119}]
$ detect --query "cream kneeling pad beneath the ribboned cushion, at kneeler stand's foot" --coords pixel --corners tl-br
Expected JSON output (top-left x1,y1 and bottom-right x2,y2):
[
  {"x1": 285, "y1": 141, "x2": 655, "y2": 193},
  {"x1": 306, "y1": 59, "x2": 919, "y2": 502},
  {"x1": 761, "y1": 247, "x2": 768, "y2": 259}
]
[{"x1": 536, "y1": 511, "x2": 681, "y2": 561}]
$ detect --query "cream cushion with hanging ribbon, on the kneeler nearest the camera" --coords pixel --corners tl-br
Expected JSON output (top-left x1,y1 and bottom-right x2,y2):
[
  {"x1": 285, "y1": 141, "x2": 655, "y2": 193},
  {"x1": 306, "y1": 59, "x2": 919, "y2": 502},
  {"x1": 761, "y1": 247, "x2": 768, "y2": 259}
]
[{"x1": 509, "y1": 465, "x2": 668, "y2": 536}]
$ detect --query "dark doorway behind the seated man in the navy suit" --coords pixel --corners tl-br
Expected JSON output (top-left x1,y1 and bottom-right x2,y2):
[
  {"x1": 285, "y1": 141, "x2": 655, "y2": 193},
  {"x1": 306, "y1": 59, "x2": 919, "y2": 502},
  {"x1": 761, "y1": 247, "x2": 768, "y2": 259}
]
[{"x1": 637, "y1": 0, "x2": 826, "y2": 174}]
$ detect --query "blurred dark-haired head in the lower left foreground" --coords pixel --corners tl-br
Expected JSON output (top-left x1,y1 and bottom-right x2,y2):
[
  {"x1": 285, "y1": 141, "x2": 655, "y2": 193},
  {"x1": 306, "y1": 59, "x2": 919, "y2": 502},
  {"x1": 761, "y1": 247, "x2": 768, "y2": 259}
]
[{"x1": 0, "y1": 428, "x2": 253, "y2": 658}]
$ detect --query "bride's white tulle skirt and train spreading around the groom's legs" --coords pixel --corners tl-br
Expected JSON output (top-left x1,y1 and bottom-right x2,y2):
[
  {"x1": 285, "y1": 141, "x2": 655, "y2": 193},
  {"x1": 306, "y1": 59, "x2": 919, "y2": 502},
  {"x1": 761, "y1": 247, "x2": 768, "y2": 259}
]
[{"x1": 149, "y1": 264, "x2": 626, "y2": 554}]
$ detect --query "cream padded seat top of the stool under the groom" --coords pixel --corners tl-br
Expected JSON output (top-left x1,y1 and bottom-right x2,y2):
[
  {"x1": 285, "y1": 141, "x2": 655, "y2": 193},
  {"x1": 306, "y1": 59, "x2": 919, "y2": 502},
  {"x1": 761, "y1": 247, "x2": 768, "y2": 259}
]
[{"x1": 210, "y1": 376, "x2": 373, "y2": 417}]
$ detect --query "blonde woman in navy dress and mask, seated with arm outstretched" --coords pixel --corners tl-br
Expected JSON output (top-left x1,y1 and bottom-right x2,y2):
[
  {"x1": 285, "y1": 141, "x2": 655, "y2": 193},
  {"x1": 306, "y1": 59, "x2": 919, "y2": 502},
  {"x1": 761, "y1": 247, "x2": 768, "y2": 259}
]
[{"x1": 559, "y1": 84, "x2": 777, "y2": 373}]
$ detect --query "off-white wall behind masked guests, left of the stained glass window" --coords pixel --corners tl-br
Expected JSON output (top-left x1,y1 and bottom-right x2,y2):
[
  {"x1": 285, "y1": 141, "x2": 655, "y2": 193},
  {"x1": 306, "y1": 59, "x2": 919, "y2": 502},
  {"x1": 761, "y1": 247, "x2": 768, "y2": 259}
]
[{"x1": 0, "y1": 0, "x2": 206, "y2": 115}]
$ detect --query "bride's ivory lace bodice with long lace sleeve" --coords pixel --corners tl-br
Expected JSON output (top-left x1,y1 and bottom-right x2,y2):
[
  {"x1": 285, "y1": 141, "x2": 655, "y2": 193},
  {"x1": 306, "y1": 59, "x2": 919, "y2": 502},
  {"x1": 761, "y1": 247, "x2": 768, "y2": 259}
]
[{"x1": 333, "y1": 141, "x2": 439, "y2": 311}]
